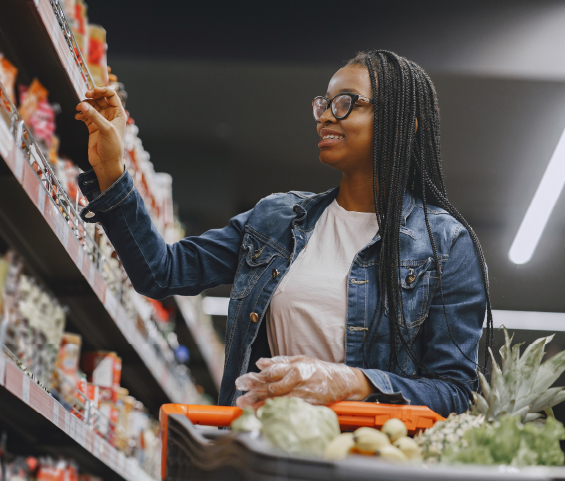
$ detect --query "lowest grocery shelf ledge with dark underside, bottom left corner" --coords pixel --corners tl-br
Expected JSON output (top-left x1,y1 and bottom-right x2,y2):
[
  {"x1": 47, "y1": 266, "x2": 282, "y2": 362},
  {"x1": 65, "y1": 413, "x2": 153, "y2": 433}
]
[{"x1": 0, "y1": 352, "x2": 153, "y2": 481}]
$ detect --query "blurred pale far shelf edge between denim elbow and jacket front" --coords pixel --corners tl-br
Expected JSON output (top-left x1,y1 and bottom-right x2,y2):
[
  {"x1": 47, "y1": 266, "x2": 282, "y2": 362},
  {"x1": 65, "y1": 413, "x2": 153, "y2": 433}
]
[{"x1": 174, "y1": 296, "x2": 224, "y2": 393}]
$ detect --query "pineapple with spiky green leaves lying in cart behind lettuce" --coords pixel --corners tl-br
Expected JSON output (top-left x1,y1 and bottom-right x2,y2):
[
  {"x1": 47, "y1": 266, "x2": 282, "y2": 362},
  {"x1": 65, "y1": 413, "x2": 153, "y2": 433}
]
[{"x1": 416, "y1": 328, "x2": 565, "y2": 462}]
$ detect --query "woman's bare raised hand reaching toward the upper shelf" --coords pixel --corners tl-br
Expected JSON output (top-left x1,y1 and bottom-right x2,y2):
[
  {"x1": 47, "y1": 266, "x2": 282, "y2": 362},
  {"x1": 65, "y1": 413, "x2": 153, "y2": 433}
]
[{"x1": 75, "y1": 87, "x2": 126, "y2": 192}]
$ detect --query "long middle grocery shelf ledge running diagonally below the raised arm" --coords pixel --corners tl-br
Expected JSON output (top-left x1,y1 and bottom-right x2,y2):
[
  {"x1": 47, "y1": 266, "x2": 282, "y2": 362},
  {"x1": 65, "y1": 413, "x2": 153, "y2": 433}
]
[{"x1": 0, "y1": 93, "x2": 199, "y2": 413}]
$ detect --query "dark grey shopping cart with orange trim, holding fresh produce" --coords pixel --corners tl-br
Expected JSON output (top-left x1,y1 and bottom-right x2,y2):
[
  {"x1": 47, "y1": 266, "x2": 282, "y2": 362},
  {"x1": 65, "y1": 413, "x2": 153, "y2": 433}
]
[{"x1": 159, "y1": 402, "x2": 565, "y2": 481}]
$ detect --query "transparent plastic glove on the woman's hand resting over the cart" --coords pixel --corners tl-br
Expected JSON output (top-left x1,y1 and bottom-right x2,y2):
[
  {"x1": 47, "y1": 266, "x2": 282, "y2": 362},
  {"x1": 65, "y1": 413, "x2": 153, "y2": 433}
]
[{"x1": 235, "y1": 356, "x2": 364, "y2": 408}]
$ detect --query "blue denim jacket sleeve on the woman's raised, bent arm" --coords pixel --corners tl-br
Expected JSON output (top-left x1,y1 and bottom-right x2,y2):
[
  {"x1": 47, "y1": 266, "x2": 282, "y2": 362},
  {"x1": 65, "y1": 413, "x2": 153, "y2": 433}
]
[{"x1": 79, "y1": 170, "x2": 251, "y2": 299}]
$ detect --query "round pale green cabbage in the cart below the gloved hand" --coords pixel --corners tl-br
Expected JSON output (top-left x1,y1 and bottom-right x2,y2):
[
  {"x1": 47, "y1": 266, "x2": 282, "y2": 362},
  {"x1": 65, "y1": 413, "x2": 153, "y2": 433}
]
[{"x1": 257, "y1": 397, "x2": 340, "y2": 456}]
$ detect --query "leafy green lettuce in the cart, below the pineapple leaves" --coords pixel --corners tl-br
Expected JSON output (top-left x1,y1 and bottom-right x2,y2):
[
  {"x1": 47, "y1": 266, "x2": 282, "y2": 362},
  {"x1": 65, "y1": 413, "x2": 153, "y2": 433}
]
[{"x1": 442, "y1": 415, "x2": 565, "y2": 466}]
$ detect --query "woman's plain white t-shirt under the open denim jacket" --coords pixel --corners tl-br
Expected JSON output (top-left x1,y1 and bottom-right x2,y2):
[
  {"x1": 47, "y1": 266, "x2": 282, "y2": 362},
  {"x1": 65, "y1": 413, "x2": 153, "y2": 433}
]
[{"x1": 267, "y1": 200, "x2": 379, "y2": 362}]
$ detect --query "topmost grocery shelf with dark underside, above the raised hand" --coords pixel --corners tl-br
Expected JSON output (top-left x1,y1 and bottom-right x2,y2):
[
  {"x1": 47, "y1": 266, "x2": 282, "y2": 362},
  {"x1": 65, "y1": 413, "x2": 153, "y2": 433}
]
[{"x1": 0, "y1": 0, "x2": 94, "y2": 170}]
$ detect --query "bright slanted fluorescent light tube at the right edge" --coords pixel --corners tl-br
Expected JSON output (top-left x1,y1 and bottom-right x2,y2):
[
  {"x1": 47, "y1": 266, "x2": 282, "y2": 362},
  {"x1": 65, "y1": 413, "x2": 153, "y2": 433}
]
[{"x1": 508, "y1": 124, "x2": 565, "y2": 264}]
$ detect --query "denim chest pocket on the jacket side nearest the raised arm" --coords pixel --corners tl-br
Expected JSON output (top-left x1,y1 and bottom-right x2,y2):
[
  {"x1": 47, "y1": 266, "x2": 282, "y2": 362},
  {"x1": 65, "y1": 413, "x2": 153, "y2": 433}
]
[{"x1": 230, "y1": 234, "x2": 280, "y2": 299}]
